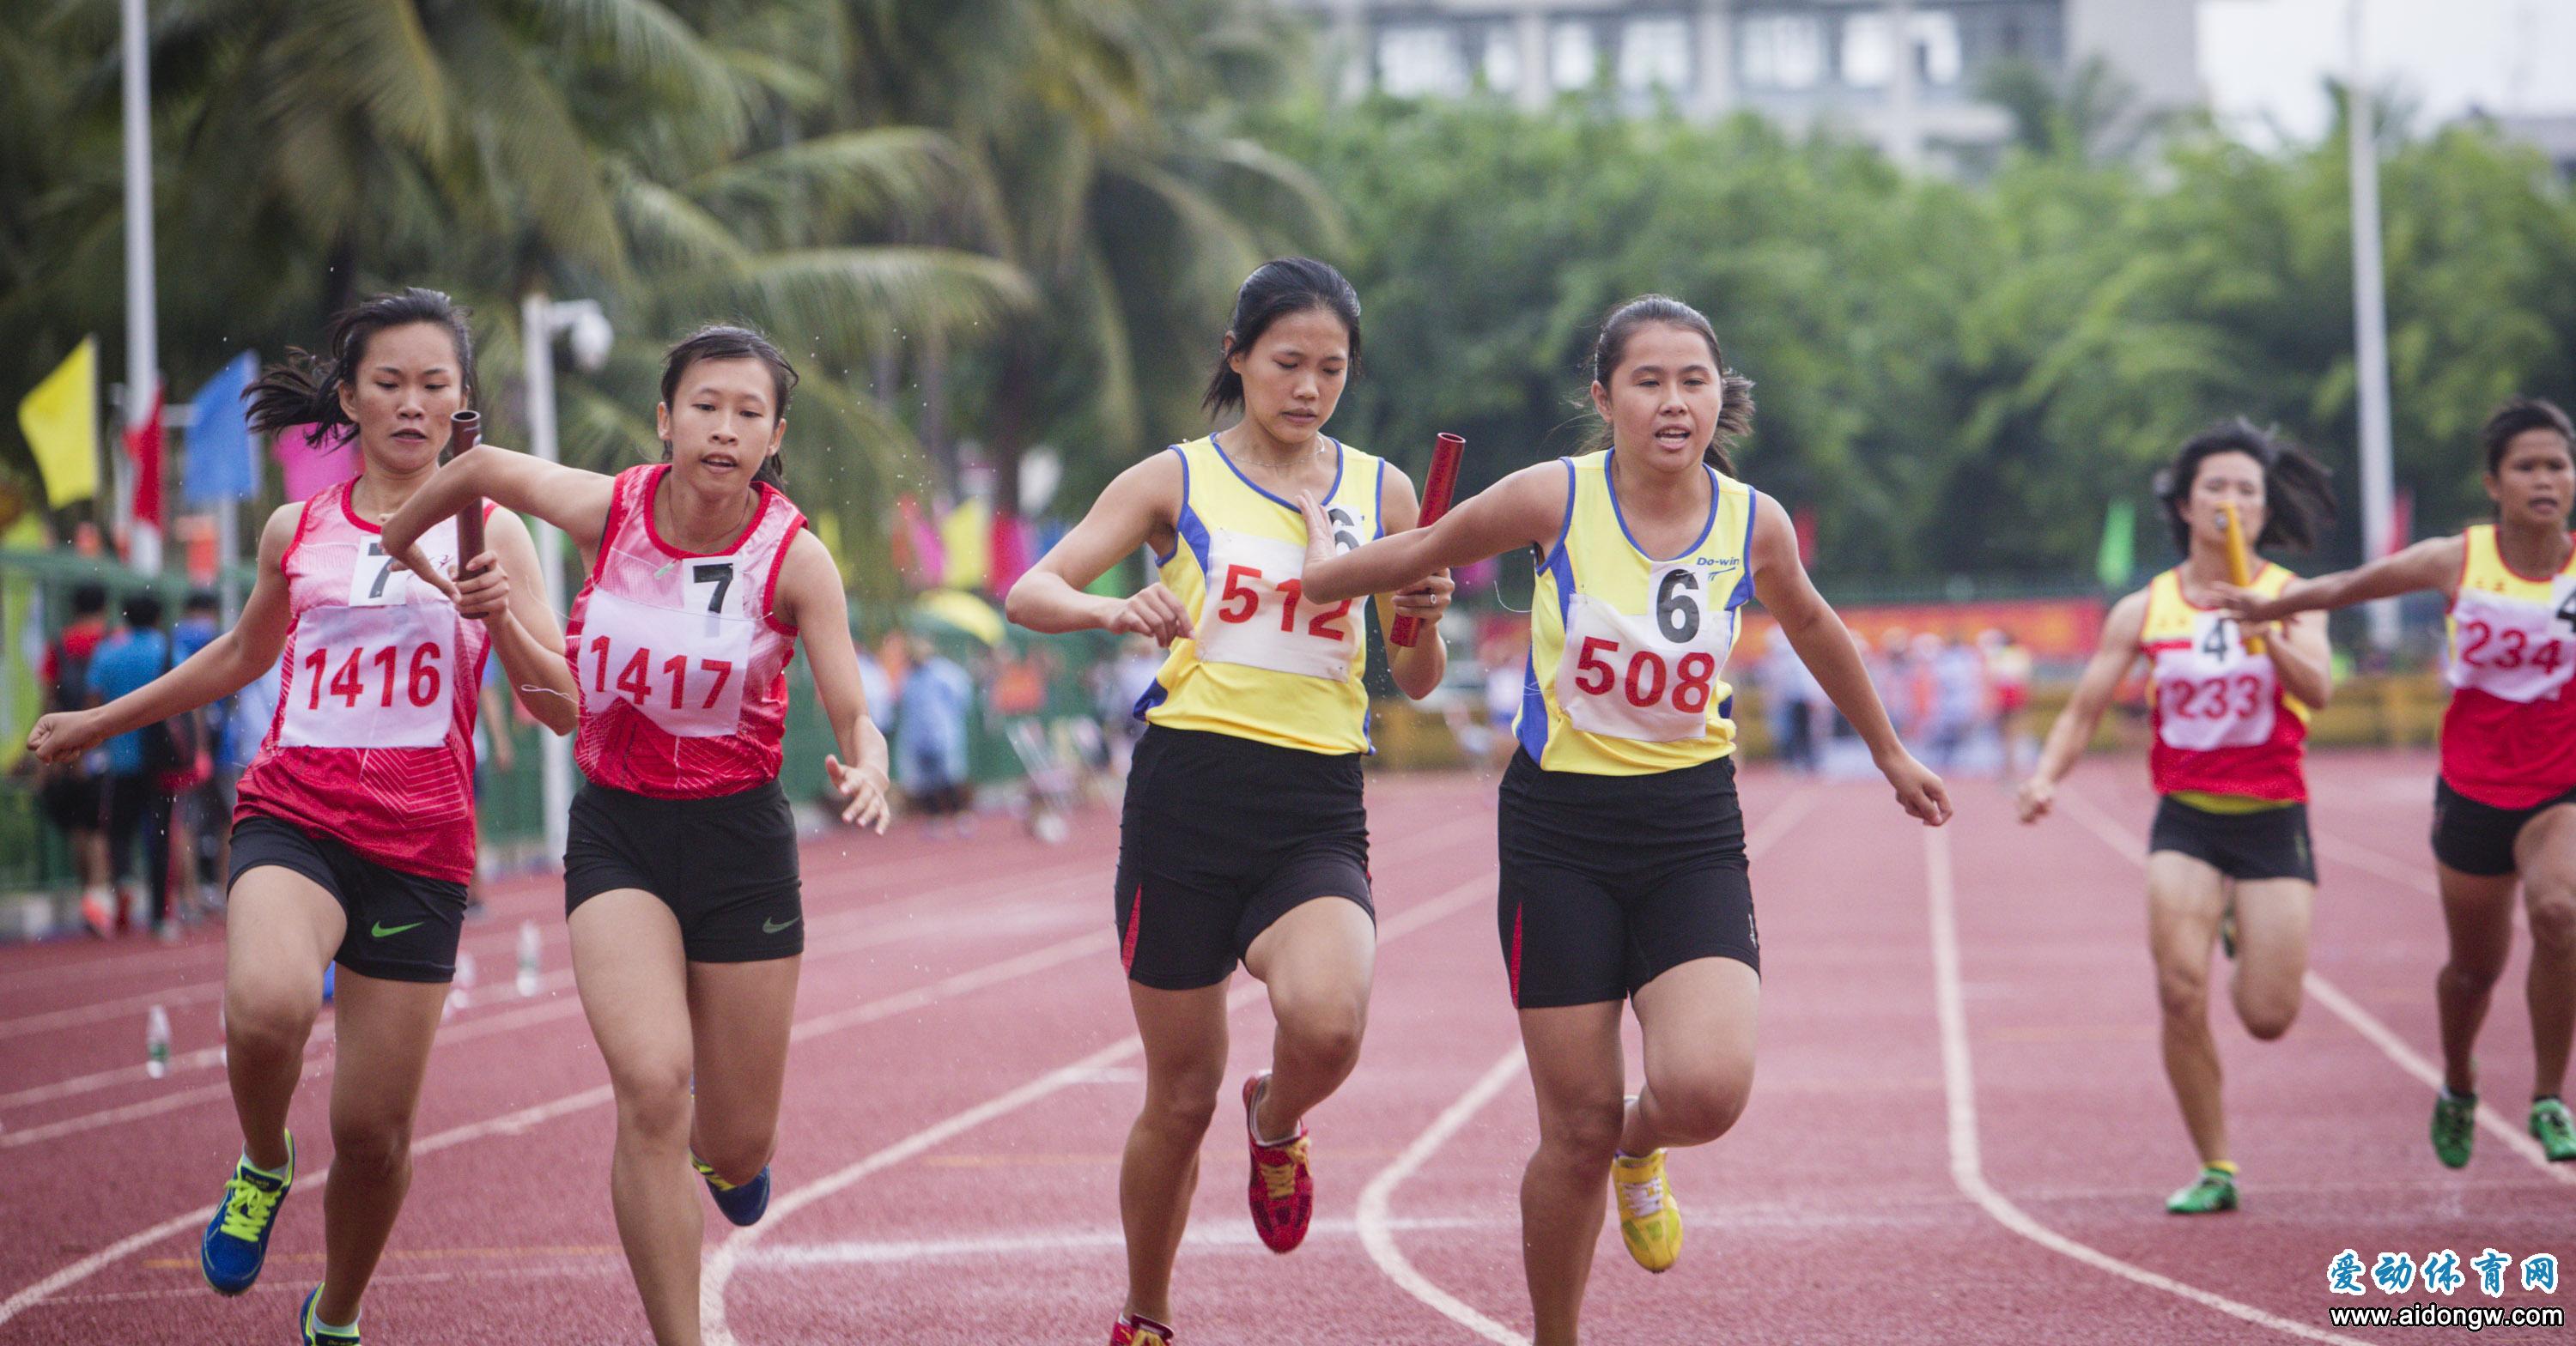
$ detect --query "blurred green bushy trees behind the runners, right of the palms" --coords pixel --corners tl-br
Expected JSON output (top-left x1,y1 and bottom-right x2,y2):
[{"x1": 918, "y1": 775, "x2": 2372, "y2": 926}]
[{"x1": 1273, "y1": 89, "x2": 2576, "y2": 579}]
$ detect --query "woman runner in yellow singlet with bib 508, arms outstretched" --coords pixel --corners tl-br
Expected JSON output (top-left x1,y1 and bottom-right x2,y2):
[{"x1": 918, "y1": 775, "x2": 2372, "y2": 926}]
[{"x1": 1306, "y1": 296, "x2": 1950, "y2": 1346}]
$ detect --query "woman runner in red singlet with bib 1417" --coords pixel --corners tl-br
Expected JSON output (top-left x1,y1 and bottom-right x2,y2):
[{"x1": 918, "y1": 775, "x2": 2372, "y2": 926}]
[{"x1": 384, "y1": 327, "x2": 886, "y2": 1346}]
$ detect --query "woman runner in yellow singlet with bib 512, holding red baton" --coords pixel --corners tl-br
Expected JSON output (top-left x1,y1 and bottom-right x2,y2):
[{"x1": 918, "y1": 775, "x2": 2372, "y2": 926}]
[{"x1": 1010, "y1": 258, "x2": 1450, "y2": 1346}]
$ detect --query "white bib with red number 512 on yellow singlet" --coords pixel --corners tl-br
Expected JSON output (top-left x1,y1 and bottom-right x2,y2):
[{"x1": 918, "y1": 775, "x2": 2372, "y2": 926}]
[{"x1": 1195, "y1": 520, "x2": 1360, "y2": 682}]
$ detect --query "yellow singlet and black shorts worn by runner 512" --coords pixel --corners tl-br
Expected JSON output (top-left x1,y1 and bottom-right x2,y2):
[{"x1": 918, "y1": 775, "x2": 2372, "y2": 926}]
[{"x1": 1115, "y1": 438, "x2": 1386, "y2": 991}]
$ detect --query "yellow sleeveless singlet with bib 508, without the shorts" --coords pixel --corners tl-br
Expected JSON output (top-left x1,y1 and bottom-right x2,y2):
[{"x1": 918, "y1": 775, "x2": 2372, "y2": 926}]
[{"x1": 1515, "y1": 451, "x2": 1754, "y2": 774}]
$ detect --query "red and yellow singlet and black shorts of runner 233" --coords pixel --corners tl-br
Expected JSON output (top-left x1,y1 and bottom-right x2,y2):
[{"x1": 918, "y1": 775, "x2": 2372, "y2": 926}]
[{"x1": 2138, "y1": 564, "x2": 2316, "y2": 882}]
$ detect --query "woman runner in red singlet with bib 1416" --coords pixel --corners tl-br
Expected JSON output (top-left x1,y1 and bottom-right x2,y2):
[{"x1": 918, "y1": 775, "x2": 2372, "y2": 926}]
[{"x1": 28, "y1": 288, "x2": 572, "y2": 1346}]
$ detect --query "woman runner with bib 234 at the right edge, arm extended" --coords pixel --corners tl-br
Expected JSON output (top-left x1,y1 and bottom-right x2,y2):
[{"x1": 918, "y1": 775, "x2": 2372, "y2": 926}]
[{"x1": 2228, "y1": 399, "x2": 2576, "y2": 1168}]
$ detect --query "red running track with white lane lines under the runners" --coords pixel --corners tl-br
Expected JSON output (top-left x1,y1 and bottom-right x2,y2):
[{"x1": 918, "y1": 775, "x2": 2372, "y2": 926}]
[{"x1": 0, "y1": 756, "x2": 2576, "y2": 1346}]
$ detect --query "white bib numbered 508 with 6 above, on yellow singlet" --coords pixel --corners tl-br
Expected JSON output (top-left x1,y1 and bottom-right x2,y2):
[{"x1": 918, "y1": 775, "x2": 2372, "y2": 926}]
[{"x1": 1556, "y1": 564, "x2": 1736, "y2": 743}]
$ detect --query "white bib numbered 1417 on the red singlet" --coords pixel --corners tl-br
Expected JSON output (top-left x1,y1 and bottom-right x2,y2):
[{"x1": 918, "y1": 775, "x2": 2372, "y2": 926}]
[{"x1": 572, "y1": 561, "x2": 760, "y2": 738}]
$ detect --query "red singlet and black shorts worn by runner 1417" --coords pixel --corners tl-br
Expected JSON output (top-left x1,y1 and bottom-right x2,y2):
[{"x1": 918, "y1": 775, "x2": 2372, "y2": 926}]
[{"x1": 564, "y1": 464, "x2": 804, "y2": 962}]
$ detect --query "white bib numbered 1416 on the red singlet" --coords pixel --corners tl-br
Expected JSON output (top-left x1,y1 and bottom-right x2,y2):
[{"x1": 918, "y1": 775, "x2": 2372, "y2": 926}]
[{"x1": 278, "y1": 538, "x2": 456, "y2": 749}]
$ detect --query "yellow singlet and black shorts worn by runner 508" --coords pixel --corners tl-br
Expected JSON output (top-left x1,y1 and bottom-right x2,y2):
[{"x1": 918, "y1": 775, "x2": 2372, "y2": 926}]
[{"x1": 1497, "y1": 451, "x2": 1762, "y2": 1009}]
